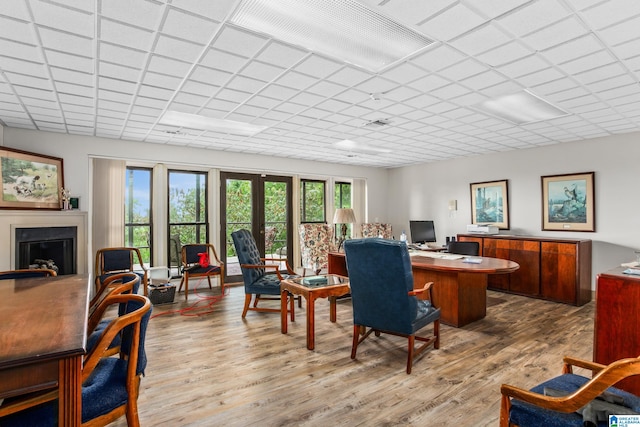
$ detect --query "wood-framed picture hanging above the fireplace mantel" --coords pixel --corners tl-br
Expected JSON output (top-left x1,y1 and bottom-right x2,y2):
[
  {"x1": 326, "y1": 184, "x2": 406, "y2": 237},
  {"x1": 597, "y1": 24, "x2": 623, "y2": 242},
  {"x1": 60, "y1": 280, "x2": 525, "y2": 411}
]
[{"x1": 0, "y1": 147, "x2": 64, "y2": 210}]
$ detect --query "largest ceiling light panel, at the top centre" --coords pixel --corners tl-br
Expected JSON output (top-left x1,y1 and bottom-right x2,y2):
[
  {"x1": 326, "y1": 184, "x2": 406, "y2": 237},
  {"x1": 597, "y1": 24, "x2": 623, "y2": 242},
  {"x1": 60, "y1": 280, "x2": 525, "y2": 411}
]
[{"x1": 230, "y1": 0, "x2": 433, "y2": 72}]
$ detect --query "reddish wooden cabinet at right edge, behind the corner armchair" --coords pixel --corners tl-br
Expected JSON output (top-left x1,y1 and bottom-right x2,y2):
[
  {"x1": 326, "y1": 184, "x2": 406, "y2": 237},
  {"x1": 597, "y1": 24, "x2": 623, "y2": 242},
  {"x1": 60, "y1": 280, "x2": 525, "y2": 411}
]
[{"x1": 593, "y1": 267, "x2": 640, "y2": 395}]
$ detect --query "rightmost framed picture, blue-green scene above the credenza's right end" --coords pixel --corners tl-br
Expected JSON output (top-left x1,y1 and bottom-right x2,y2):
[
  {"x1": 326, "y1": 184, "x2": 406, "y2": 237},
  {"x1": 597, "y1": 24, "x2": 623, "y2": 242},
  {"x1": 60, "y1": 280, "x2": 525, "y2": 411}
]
[{"x1": 542, "y1": 172, "x2": 596, "y2": 231}]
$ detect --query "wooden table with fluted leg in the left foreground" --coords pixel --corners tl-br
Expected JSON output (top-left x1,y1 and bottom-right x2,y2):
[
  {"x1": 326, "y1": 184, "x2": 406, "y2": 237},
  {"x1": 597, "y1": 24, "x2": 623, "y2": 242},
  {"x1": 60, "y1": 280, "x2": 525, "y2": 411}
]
[{"x1": 0, "y1": 275, "x2": 90, "y2": 426}]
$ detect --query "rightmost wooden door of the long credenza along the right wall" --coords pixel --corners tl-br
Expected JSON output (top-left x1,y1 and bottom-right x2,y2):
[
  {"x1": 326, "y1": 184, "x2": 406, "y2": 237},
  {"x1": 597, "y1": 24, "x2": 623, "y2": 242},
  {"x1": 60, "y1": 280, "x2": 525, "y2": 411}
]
[{"x1": 541, "y1": 242, "x2": 578, "y2": 304}]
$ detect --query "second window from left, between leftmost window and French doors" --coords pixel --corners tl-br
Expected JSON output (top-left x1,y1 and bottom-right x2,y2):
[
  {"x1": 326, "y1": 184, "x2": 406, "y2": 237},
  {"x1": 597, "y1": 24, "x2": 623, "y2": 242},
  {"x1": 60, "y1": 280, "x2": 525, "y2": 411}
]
[{"x1": 169, "y1": 170, "x2": 209, "y2": 244}]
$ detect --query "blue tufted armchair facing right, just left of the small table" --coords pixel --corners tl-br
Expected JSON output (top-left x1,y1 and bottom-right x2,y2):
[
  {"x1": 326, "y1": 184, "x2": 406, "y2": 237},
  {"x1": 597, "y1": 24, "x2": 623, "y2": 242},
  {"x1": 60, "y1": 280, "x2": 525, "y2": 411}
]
[{"x1": 231, "y1": 229, "x2": 295, "y2": 320}]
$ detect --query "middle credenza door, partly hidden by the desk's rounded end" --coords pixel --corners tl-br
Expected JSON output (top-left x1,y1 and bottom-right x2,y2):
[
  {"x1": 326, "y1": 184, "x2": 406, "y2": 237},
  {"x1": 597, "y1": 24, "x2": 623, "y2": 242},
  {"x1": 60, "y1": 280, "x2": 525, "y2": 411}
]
[{"x1": 509, "y1": 240, "x2": 540, "y2": 296}]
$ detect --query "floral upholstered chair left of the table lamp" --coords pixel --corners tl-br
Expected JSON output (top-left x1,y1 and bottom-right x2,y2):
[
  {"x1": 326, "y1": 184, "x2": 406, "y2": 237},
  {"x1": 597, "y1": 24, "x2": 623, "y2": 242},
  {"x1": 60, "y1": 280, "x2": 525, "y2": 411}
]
[{"x1": 298, "y1": 224, "x2": 337, "y2": 274}]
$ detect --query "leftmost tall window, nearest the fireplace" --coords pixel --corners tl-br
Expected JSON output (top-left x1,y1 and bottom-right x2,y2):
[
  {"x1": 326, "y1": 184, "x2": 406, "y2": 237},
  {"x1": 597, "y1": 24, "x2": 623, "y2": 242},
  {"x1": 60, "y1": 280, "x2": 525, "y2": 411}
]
[{"x1": 124, "y1": 167, "x2": 153, "y2": 265}]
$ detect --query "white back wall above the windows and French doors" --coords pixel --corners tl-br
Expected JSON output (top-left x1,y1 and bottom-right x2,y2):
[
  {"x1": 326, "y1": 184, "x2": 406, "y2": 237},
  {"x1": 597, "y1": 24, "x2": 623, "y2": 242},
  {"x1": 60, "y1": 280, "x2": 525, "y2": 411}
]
[{"x1": 4, "y1": 128, "x2": 388, "y2": 270}]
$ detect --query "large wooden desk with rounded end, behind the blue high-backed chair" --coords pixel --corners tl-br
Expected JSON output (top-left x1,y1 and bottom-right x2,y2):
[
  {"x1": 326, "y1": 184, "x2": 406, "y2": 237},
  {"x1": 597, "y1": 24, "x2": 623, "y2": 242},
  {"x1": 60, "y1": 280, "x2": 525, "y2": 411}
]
[{"x1": 329, "y1": 252, "x2": 520, "y2": 327}]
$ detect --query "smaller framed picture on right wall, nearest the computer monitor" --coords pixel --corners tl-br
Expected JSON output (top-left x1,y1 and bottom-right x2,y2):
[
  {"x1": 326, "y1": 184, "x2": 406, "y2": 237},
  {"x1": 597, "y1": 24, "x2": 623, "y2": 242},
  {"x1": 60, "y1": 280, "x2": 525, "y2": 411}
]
[{"x1": 471, "y1": 179, "x2": 509, "y2": 230}]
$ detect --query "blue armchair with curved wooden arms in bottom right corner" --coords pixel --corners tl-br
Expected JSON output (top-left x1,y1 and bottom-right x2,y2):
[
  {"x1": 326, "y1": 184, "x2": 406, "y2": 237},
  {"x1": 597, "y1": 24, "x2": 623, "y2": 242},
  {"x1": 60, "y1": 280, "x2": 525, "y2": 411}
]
[{"x1": 500, "y1": 357, "x2": 640, "y2": 427}]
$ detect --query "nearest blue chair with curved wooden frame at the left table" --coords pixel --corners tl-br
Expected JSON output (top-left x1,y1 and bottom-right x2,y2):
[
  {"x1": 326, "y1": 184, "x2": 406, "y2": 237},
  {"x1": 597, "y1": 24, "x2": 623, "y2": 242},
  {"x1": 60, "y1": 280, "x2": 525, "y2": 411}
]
[{"x1": 0, "y1": 294, "x2": 151, "y2": 427}]
